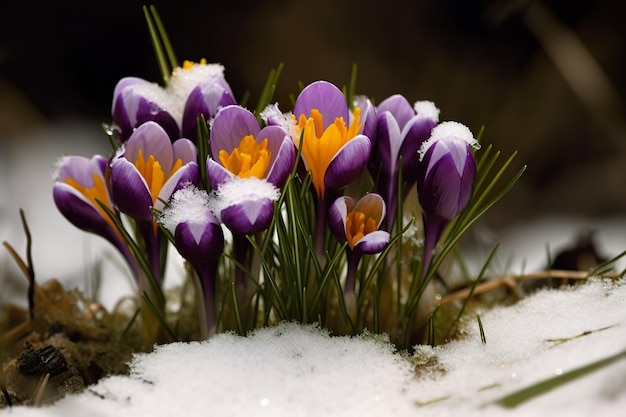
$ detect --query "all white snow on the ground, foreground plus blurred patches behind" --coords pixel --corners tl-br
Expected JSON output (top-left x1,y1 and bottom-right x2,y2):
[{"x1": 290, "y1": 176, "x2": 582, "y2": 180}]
[{"x1": 0, "y1": 122, "x2": 626, "y2": 417}]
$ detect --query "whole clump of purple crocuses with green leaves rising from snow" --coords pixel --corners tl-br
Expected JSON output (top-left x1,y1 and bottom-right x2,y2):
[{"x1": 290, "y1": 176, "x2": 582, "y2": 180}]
[{"x1": 48, "y1": 16, "x2": 520, "y2": 347}]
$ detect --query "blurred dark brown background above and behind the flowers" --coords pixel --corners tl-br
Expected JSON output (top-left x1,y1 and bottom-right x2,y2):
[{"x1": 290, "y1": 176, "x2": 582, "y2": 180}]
[{"x1": 0, "y1": 0, "x2": 626, "y2": 225}]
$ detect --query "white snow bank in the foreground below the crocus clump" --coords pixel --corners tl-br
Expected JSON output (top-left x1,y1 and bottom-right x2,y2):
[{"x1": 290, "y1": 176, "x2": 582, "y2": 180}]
[{"x1": 0, "y1": 279, "x2": 626, "y2": 417}]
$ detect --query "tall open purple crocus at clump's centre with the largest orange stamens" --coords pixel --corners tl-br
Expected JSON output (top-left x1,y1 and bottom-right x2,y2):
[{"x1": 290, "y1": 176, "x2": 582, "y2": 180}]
[{"x1": 293, "y1": 81, "x2": 371, "y2": 200}]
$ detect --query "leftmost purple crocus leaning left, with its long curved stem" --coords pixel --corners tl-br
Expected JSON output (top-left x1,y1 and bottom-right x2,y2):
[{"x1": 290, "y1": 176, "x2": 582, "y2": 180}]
[{"x1": 52, "y1": 155, "x2": 138, "y2": 277}]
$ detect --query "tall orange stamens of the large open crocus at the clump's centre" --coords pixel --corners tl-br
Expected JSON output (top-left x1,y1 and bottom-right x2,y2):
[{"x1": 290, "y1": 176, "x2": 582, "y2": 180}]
[{"x1": 295, "y1": 107, "x2": 361, "y2": 198}]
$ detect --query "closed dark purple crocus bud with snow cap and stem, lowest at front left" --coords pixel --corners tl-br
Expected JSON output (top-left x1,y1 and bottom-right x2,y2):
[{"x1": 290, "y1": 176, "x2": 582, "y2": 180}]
[{"x1": 159, "y1": 185, "x2": 224, "y2": 336}]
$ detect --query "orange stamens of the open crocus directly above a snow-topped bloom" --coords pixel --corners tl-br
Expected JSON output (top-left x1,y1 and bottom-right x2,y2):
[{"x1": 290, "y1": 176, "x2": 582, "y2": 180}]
[{"x1": 219, "y1": 135, "x2": 272, "y2": 178}]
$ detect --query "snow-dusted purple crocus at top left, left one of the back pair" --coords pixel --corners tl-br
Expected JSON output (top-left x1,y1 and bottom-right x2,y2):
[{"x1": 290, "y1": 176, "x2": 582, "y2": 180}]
[{"x1": 111, "y1": 77, "x2": 180, "y2": 142}]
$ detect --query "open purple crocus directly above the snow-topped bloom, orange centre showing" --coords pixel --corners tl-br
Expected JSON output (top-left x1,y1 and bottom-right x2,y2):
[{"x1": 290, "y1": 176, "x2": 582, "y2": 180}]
[{"x1": 207, "y1": 105, "x2": 296, "y2": 188}]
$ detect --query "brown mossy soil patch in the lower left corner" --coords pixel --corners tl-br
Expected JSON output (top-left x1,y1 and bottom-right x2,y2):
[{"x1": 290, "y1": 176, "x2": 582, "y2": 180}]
[{"x1": 0, "y1": 280, "x2": 138, "y2": 408}]
